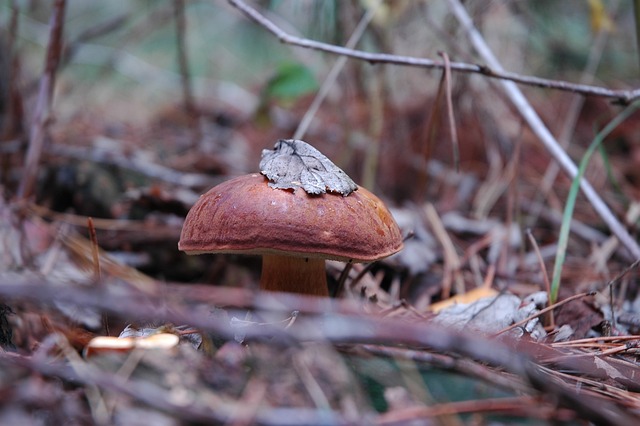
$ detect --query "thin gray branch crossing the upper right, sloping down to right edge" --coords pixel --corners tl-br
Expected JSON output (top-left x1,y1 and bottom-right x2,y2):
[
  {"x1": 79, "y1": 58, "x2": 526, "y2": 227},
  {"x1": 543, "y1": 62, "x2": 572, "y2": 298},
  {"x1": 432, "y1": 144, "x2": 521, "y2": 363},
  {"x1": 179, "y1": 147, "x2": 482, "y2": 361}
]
[{"x1": 228, "y1": 0, "x2": 640, "y2": 104}]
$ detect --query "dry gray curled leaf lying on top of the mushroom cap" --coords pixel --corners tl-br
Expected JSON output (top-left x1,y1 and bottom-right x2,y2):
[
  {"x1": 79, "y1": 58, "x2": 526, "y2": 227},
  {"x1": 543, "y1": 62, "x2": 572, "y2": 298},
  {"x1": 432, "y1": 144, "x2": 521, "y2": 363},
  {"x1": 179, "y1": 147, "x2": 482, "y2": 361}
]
[{"x1": 260, "y1": 139, "x2": 358, "y2": 197}]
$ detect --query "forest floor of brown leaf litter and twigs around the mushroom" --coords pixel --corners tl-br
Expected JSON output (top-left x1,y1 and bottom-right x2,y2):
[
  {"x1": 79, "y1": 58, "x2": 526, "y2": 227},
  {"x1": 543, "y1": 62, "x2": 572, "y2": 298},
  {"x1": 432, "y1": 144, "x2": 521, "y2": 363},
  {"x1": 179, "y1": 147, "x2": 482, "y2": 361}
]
[{"x1": 0, "y1": 1, "x2": 640, "y2": 425}]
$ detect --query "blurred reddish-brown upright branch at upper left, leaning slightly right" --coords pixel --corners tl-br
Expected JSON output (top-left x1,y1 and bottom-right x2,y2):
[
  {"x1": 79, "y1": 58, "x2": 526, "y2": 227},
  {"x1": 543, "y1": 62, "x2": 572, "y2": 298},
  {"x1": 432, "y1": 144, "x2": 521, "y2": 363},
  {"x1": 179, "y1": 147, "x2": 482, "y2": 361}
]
[{"x1": 18, "y1": 0, "x2": 67, "y2": 199}]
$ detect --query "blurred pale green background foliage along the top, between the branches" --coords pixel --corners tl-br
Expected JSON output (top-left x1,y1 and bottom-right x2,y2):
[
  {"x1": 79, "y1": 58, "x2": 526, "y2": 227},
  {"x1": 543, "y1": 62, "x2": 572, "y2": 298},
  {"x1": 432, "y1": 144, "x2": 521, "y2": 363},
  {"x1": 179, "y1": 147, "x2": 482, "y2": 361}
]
[{"x1": 0, "y1": 0, "x2": 638, "y2": 125}]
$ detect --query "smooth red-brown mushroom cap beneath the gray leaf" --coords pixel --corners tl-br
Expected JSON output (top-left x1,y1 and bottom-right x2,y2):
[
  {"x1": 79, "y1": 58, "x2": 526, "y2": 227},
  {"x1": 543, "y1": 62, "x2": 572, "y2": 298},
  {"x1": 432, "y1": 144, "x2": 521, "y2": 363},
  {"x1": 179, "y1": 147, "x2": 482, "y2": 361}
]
[{"x1": 178, "y1": 174, "x2": 402, "y2": 262}]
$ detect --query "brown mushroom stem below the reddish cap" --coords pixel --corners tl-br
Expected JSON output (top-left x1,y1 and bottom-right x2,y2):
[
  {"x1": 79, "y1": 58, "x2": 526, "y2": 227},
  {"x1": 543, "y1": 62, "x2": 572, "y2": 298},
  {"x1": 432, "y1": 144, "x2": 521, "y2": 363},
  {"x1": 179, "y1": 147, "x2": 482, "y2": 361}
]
[{"x1": 260, "y1": 254, "x2": 329, "y2": 297}]
